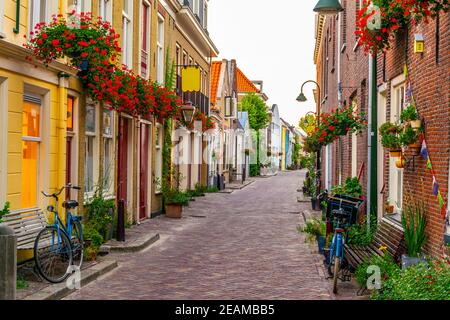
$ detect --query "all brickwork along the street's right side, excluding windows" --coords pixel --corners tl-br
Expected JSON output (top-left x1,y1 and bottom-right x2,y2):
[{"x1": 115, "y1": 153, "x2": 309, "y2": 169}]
[{"x1": 317, "y1": 0, "x2": 450, "y2": 256}]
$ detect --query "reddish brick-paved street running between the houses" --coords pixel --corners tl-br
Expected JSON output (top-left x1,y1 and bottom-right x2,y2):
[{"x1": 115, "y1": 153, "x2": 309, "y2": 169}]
[{"x1": 66, "y1": 171, "x2": 334, "y2": 300}]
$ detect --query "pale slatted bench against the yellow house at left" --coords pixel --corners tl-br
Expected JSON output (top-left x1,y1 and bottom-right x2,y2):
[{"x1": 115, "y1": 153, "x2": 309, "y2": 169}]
[{"x1": 2, "y1": 210, "x2": 47, "y2": 254}]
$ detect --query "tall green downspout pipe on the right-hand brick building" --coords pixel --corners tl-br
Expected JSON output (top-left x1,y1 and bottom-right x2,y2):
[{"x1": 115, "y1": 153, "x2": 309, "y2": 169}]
[{"x1": 366, "y1": 54, "x2": 378, "y2": 232}]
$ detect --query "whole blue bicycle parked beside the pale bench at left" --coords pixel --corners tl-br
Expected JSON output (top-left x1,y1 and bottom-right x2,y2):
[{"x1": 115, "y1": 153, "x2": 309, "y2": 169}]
[{"x1": 34, "y1": 184, "x2": 83, "y2": 283}]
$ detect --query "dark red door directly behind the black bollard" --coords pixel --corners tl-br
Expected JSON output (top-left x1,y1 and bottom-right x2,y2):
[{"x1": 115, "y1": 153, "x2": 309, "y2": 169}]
[{"x1": 117, "y1": 117, "x2": 129, "y2": 205}]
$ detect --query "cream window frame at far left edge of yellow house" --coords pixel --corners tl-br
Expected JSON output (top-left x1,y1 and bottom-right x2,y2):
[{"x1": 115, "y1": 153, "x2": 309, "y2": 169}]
[{"x1": 0, "y1": 77, "x2": 8, "y2": 205}]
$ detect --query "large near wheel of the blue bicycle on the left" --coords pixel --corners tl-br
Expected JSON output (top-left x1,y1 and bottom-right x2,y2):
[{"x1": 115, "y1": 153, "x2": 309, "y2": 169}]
[{"x1": 34, "y1": 226, "x2": 72, "y2": 283}]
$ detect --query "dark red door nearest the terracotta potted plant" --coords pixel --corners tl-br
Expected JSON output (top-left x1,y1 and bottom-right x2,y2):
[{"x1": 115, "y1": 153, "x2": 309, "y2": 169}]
[{"x1": 139, "y1": 123, "x2": 150, "y2": 220}]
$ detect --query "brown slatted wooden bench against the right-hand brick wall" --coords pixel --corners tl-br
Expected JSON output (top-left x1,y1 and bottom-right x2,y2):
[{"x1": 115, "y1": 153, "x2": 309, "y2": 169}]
[{"x1": 345, "y1": 221, "x2": 406, "y2": 270}]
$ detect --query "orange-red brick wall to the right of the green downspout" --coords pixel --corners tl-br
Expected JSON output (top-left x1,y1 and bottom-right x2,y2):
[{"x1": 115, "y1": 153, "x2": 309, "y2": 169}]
[{"x1": 378, "y1": 15, "x2": 450, "y2": 256}]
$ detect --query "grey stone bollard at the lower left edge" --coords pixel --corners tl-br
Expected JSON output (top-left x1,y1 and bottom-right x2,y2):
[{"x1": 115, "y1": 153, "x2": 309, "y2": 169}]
[{"x1": 0, "y1": 225, "x2": 17, "y2": 300}]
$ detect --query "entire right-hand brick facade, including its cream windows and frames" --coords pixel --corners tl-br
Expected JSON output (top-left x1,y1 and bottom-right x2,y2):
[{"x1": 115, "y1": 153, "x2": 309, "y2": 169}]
[{"x1": 314, "y1": 0, "x2": 450, "y2": 256}]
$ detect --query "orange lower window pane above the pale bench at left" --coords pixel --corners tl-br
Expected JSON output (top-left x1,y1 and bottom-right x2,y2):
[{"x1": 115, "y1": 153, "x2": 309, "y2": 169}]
[{"x1": 22, "y1": 141, "x2": 39, "y2": 208}]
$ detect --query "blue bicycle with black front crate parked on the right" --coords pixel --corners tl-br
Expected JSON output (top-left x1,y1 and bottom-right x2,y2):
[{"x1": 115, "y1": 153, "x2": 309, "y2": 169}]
[{"x1": 325, "y1": 209, "x2": 351, "y2": 294}]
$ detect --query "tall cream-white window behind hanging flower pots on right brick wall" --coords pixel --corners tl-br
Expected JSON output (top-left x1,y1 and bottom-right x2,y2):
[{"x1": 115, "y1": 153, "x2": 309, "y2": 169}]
[{"x1": 389, "y1": 74, "x2": 406, "y2": 219}]
